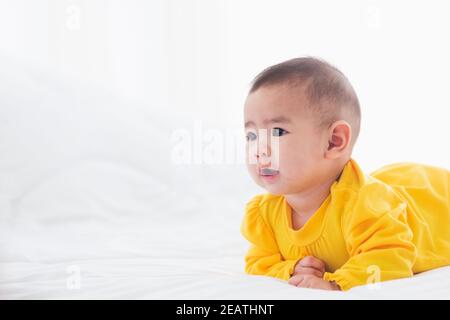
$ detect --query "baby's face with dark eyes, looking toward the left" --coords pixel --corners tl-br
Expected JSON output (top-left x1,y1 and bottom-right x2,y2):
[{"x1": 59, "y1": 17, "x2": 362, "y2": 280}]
[{"x1": 244, "y1": 85, "x2": 329, "y2": 195}]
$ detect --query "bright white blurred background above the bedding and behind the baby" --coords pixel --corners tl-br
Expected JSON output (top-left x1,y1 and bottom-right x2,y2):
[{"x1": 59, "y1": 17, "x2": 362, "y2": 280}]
[{"x1": 0, "y1": 0, "x2": 450, "y2": 171}]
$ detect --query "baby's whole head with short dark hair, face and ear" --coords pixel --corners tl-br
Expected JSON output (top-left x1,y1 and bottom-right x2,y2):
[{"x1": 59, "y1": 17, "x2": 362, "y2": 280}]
[{"x1": 244, "y1": 57, "x2": 361, "y2": 195}]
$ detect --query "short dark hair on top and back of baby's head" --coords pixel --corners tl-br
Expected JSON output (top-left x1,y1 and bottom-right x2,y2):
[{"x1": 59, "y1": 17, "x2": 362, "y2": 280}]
[{"x1": 249, "y1": 57, "x2": 361, "y2": 145}]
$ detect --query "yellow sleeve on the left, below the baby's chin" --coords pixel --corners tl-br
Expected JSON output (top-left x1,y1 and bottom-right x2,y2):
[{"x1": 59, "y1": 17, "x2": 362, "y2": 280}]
[{"x1": 241, "y1": 196, "x2": 297, "y2": 280}]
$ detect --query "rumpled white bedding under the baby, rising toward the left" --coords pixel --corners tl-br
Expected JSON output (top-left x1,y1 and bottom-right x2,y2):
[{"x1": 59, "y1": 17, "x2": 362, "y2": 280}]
[{"x1": 0, "y1": 57, "x2": 450, "y2": 299}]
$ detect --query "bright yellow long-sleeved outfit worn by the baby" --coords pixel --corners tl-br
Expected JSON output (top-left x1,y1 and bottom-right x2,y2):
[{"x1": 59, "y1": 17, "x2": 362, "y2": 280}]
[{"x1": 241, "y1": 159, "x2": 450, "y2": 290}]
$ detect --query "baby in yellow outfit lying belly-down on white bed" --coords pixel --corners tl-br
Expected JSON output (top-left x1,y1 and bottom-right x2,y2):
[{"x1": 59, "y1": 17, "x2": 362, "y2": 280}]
[{"x1": 241, "y1": 57, "x2": 450, "y2": 290}]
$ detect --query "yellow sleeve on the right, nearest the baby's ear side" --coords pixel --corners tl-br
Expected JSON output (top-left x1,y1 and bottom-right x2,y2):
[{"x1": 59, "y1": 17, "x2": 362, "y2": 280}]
[{"x1": 324, "y1": 185, "x2": 417, "y2": 290}]
